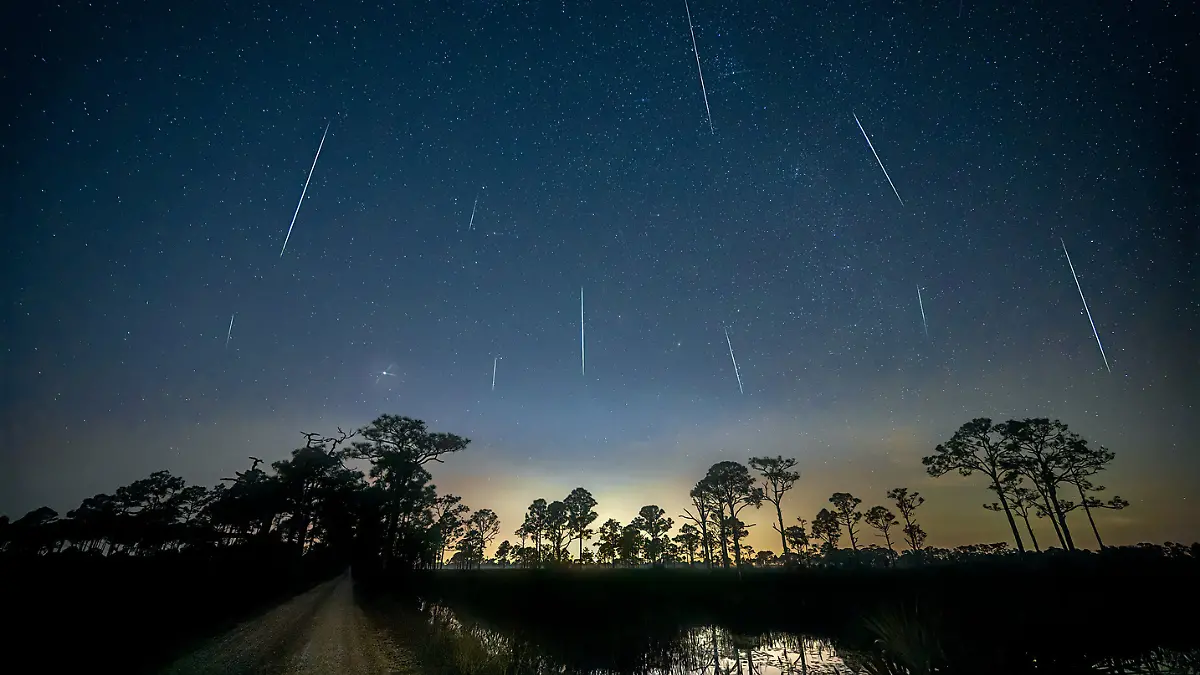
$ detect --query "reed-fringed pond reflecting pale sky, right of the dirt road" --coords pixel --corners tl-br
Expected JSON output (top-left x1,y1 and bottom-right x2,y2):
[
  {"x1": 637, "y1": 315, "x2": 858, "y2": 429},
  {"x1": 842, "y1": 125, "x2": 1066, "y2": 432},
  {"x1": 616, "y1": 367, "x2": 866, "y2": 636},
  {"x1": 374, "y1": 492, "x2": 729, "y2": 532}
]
[{"x1": 376, "y1": 603, "x2": 1200, "y2": 675}]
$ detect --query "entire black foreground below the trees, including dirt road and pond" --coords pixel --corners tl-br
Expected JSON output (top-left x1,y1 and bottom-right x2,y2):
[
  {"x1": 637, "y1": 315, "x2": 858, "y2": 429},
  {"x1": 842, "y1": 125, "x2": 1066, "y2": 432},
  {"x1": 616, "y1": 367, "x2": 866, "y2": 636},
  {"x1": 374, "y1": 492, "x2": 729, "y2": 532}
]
[{"x1": 6, "y1": 549, "x2": 1200, "y2": 675}]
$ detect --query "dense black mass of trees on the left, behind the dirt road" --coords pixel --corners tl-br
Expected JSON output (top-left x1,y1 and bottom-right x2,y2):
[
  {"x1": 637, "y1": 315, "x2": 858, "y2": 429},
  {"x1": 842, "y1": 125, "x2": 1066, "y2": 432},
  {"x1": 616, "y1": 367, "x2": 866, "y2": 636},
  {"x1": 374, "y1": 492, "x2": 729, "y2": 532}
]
[{"x1": 0, "y1": 416, "x2": 498, "y2": 568}]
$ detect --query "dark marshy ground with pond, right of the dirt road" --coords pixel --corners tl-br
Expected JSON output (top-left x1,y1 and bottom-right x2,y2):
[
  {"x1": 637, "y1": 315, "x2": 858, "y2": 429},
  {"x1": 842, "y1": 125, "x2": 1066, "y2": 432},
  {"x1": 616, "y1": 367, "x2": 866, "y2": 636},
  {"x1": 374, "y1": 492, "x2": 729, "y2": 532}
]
[{"x1": 393, "y1": 551, "x2": 1200, "y2": 675}]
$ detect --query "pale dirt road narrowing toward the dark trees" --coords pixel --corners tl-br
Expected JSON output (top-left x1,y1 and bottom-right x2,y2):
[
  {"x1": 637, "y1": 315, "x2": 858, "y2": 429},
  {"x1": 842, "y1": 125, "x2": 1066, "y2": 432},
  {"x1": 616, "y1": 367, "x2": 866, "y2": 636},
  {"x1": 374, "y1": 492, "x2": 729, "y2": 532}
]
[{"x1": 162, "y1": 573, "x2": 415, "y2": 675}]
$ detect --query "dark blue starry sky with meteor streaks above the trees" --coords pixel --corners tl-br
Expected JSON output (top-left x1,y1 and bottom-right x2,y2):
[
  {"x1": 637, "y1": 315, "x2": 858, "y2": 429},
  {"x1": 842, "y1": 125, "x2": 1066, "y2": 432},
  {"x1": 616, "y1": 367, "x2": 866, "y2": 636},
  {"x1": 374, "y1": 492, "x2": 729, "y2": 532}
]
[{"x1": 0, "y1": 0, "x2": 1200, "y2": 546}]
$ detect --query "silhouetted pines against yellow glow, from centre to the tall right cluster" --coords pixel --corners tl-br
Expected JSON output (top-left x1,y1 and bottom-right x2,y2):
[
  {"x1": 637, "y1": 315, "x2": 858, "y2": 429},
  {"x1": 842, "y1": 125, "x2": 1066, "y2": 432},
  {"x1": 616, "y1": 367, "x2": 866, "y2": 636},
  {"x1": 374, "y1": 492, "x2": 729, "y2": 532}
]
[{"x1": 477, "y1": 418, "x2": 1129, "y2": 568}]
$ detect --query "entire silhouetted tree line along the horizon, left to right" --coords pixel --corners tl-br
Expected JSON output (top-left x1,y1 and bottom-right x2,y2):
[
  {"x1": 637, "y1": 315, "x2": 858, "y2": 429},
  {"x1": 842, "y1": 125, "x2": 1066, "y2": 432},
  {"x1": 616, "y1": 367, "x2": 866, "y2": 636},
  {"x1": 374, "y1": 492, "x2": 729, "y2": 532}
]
[{"x1": 0, "y1": 414, "x2": 1129, "y2": 569}]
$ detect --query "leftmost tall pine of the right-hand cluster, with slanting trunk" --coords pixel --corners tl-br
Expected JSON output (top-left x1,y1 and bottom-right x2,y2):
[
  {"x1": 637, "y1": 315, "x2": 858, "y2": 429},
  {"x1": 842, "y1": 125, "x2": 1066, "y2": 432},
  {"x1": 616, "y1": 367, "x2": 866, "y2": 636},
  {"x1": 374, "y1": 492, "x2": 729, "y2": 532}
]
[{"x1": 920, "y1": 417, "x2": 1025, "y2": 552}]
